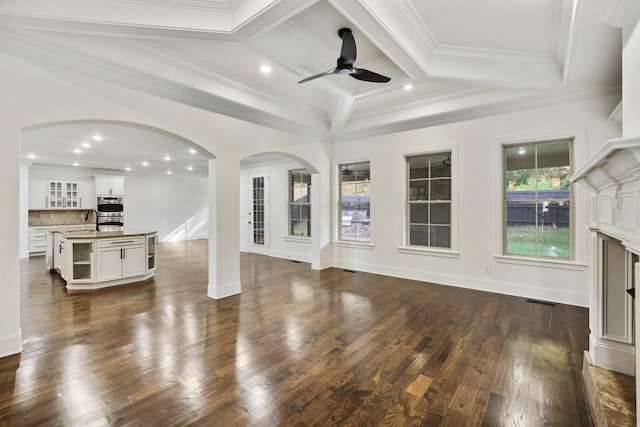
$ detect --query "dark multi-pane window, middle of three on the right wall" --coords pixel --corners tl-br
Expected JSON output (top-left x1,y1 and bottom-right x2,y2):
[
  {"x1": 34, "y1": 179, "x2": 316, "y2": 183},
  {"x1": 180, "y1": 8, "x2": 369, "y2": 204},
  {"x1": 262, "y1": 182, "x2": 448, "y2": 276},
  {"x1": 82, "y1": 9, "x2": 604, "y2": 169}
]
[{"x1": 406, "y1": 151, "x2": 452, "y2": 249}]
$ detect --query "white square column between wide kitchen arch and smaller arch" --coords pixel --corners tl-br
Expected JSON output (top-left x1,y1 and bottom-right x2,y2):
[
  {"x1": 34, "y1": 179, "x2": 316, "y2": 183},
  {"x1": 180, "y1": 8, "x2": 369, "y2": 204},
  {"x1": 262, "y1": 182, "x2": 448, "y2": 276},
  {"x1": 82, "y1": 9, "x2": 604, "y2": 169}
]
[{"x1": 207, "y1": 156, "x2": 241, "y2": 299}]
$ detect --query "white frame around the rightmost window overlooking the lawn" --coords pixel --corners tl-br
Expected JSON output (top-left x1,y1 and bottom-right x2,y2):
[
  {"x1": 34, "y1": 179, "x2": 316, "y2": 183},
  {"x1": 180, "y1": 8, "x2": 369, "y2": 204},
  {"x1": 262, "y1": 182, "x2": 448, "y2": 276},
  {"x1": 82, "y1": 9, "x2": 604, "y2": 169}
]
[{"x1": 502, "y1": 139, "x2": 580, "y2": 266}]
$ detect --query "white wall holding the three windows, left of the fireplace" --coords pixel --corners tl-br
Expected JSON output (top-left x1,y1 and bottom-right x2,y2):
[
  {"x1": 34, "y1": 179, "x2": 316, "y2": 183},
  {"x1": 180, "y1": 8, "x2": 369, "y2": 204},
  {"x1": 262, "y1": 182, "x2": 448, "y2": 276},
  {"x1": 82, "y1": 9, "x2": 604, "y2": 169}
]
[{"x1": 324, "y1": 97, "x2": 620, "y2": 306}]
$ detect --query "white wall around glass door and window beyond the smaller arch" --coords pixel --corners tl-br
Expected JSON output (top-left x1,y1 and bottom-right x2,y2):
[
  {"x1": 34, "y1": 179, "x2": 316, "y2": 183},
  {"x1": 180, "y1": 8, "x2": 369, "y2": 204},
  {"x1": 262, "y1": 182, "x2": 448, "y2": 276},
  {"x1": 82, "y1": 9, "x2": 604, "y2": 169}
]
[{"x1": 240, "y1": 160, "x2": 314, "y2": 262}]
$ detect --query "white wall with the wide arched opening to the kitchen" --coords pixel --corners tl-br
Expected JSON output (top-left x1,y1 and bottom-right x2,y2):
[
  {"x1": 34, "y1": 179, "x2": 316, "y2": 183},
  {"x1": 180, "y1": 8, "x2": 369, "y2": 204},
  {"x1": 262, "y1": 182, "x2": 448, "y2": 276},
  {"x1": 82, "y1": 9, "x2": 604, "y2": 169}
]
[{"x1": 0, "y1": 52, "x2": 312, "y2": 357}]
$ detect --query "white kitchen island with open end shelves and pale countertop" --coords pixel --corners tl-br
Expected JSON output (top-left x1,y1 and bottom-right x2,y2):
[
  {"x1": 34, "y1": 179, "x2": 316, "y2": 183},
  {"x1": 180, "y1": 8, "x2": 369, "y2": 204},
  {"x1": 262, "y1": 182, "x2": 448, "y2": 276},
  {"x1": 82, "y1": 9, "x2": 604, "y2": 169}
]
[{"x1": 47, "y1": 227, "x2": 158, "y2": 290}]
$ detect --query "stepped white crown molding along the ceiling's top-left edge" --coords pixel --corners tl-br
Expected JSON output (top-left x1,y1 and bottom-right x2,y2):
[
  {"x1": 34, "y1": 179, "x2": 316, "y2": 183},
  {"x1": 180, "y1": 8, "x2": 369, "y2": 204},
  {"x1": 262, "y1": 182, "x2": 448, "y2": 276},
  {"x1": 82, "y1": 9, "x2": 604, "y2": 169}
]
[{"x1": 0, "y1": 0, "x2": 280, "y2": 37}]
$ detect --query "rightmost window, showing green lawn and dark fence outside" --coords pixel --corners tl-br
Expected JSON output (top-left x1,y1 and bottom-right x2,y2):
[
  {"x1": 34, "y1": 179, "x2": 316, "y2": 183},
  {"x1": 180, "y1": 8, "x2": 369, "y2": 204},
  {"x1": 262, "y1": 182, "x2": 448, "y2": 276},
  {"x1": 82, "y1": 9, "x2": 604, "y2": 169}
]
[{"x1": 503, "y1": 140, "x2": 572, "y2": 259}]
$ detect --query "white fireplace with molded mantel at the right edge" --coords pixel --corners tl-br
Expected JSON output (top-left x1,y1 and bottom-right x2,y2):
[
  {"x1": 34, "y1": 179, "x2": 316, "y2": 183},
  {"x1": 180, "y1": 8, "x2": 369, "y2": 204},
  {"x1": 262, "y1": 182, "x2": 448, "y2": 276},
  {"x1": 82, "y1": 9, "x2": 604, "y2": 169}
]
[{"x1": 571, "y1": 137, "x2": 640, "y2": 424}]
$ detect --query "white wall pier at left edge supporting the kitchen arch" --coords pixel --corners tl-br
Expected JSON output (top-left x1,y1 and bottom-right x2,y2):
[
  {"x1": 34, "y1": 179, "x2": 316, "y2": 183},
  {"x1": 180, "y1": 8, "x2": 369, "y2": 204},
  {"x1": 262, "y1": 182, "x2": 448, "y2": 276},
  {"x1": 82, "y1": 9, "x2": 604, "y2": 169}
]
[{"x1": 0, "y1": 126, "x2": 22, "y2": 357}]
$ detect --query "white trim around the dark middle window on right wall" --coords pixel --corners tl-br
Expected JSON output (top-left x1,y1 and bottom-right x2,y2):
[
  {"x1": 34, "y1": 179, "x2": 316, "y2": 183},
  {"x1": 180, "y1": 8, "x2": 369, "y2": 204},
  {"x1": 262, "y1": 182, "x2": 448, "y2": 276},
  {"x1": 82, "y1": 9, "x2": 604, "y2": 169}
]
[{"x1": 397, "y1": 144, "x2": 460, "y2": 257}]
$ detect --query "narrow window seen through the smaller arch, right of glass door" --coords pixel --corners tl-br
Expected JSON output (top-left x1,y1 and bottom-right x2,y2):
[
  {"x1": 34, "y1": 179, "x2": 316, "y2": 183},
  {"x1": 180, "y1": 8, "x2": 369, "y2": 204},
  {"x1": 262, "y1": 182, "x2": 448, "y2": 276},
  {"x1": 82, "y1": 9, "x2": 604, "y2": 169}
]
[{"x1": 289, "y1": 170, "x2": 311, "y2": 237}]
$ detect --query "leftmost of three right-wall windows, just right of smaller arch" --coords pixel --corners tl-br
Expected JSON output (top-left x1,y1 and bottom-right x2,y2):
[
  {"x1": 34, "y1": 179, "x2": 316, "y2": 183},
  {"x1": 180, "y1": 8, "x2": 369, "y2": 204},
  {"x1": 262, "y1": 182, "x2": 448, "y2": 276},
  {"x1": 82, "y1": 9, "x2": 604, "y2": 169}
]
[{"x1": 339, "y1": 162, "x2": 371, "y2": 242}]
